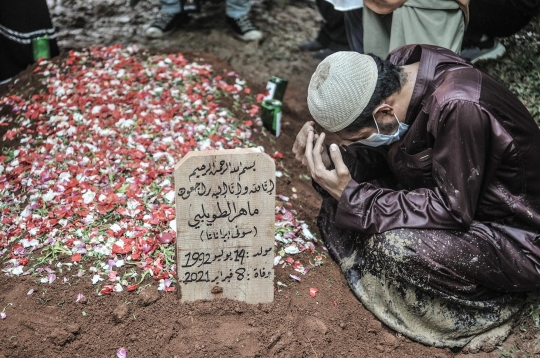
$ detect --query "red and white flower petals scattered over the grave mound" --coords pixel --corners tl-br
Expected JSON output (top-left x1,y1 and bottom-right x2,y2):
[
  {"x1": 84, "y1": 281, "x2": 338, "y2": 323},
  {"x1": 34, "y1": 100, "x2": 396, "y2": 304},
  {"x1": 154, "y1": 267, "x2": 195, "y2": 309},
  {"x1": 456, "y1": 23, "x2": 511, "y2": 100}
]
[{"x1": 0, "y1": 46, "x2": 324, "y2": 294}]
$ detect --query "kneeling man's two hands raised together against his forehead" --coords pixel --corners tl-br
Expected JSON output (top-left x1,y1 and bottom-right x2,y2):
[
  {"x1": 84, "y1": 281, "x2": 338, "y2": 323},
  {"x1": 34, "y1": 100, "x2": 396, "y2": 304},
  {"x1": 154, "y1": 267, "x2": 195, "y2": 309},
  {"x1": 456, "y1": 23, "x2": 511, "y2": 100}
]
[{"x1": 293, "y1": 122, "x2": 351, "y2": 200}]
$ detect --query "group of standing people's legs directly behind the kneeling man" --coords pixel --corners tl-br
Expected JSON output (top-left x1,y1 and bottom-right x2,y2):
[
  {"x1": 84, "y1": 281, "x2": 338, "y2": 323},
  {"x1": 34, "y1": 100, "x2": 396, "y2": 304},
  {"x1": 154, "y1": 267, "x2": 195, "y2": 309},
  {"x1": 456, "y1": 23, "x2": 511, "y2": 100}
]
[{"x1": 300, "y1": 0, "x2": 540, "y2": 63}]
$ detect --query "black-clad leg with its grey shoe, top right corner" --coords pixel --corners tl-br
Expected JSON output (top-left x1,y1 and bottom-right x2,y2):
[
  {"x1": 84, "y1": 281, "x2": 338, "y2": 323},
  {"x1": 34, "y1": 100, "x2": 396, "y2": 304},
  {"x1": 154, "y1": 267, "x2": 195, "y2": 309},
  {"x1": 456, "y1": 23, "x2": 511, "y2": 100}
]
[{"x1": 461, "y1": 0, "x2": 540, "y2": 63}]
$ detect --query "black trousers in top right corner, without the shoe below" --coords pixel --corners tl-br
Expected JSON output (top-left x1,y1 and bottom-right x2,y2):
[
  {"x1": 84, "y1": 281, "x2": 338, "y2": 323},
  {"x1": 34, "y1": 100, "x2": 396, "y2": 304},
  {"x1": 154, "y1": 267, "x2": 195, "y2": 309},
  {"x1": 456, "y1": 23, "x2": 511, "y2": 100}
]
[{"x1": 465, "y1": 0, "x2": 540, "y2": 38}]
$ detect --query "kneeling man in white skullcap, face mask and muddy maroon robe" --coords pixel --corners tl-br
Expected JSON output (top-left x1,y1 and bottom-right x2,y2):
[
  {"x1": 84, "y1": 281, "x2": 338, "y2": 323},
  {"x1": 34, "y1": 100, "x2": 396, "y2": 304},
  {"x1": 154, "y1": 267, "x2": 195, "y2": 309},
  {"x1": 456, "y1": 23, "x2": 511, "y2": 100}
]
[{"x1": 293, "y1": 45, "x2": 540, "y2": 347}]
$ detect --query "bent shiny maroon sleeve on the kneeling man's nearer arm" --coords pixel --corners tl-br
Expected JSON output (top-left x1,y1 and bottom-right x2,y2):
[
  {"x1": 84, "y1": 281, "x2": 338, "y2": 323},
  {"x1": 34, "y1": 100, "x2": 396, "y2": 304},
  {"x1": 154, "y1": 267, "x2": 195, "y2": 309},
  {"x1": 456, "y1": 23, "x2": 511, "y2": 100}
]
[{"x1": 336, "y1": 100, "x2": 490, "y2": 233}]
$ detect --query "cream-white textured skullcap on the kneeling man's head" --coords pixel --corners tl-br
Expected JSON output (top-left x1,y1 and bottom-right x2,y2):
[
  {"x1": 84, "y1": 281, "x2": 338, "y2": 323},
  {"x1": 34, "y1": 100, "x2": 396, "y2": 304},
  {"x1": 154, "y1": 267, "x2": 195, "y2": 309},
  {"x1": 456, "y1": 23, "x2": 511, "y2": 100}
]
[{"x1": 308, "y1": 51, "x2": 378, "y2": 132}]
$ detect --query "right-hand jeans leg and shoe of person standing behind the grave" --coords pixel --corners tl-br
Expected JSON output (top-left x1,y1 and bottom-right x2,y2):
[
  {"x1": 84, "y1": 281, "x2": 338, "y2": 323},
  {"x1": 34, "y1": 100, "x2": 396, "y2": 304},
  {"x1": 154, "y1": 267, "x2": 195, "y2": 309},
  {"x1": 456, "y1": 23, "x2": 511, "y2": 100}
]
[{"x1": 225, "y1": 0, "x2": 263, "y2": 41}]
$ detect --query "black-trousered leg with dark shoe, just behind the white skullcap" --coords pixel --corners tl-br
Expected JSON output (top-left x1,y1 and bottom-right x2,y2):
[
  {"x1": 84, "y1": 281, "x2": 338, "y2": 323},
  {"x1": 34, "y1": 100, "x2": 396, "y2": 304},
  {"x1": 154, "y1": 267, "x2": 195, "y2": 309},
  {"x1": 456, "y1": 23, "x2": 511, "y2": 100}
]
[{"x1": 299, "y1": 0, "x2": 350, "y2": 60}]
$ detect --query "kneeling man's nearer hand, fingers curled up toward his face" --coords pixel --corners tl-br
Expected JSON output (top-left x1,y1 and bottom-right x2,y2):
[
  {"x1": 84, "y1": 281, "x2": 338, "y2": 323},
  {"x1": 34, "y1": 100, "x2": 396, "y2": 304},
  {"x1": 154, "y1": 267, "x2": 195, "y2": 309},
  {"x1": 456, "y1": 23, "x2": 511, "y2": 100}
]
[{"x1": 305, "y1": 132, "x2": 351, "y2": 200}]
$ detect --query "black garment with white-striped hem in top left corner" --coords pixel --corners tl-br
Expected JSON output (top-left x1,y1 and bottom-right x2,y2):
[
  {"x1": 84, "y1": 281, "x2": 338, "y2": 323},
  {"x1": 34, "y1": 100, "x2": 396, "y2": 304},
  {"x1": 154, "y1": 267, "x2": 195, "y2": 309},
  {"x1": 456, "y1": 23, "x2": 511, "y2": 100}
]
[{"x1": 0, "y1": 0, "x2": 59, "y2": 83}]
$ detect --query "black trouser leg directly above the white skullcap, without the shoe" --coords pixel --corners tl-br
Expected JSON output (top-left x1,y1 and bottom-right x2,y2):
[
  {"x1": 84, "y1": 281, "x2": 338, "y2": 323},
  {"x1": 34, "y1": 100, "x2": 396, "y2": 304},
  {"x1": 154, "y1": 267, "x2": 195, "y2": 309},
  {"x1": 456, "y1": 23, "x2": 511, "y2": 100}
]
[{"x1": 317, "y1": 0, "x2": 349, "y2": 51}]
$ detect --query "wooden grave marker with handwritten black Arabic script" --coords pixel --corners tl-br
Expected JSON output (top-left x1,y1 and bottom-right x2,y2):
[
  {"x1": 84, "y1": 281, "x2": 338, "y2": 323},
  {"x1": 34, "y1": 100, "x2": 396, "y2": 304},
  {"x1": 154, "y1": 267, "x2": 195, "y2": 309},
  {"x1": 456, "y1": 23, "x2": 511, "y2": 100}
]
[{"x1": 174, "y1": 149, "x2": 276, "y2": 303}]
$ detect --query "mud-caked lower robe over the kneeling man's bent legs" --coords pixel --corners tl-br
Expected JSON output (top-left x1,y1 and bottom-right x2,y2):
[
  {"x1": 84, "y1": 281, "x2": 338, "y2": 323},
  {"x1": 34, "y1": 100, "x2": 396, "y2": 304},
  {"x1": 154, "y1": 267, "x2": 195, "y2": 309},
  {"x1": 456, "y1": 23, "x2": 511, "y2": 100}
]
[{"x1": 318, "y1": 193, "x2": 526, "y2": 347}]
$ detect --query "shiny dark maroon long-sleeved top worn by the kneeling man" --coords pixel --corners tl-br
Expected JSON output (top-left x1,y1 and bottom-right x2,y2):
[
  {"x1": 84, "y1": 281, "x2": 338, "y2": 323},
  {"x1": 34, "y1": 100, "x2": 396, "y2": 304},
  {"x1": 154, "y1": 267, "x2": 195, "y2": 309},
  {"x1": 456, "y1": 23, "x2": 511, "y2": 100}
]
[{"x1": 335, "y1": 45, "x2": 540, "y2": 290}]
